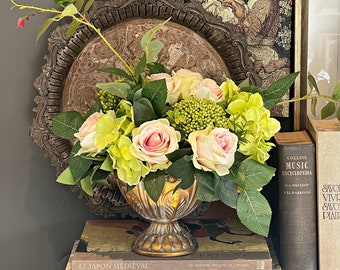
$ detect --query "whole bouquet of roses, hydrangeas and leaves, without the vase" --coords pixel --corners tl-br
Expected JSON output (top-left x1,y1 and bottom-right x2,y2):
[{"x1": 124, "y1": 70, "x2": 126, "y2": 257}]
[{"x1": 11, "y1": 0, "x2": 308, "y2": 235}]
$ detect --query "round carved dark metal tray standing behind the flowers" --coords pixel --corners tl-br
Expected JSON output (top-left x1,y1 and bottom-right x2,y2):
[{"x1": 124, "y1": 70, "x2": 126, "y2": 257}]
[{"x1": 30, "y1": 0, "x2": 259, "y2": 217}]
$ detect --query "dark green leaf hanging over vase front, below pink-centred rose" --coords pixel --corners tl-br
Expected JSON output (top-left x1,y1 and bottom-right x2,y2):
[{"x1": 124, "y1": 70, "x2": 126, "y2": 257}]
[{"x1": 144, "y1": 170, "x2": 165, "y2": 202}]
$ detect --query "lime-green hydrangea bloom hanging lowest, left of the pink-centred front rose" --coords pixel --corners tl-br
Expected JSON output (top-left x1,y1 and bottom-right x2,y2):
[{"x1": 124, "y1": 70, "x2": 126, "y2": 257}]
[{"x1": 107, "y1": 135, "x2": 150, "y2": 185}]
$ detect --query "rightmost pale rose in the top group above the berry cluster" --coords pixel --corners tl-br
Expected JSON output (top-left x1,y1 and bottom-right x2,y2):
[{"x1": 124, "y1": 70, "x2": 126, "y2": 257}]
[{"x1": 190, "y1": 79, "x2": 223, "y2": 102}]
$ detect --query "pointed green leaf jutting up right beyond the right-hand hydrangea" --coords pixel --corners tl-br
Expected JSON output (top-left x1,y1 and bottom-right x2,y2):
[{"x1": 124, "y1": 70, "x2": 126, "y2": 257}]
[{"x1": 262, "y1": 72, "x2": 299, "y2": 109}]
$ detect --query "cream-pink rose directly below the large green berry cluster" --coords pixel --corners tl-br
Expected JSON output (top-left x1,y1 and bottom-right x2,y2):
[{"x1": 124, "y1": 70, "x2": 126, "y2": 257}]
[{"x1": 188, "y1": 127, "x2": 238, "y2": 176}]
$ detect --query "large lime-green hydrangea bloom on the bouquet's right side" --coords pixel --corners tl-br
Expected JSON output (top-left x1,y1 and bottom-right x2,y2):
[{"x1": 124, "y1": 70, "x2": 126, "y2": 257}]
[{"x1": 227, "y1": 92, "x2": 280, "y2": 163}]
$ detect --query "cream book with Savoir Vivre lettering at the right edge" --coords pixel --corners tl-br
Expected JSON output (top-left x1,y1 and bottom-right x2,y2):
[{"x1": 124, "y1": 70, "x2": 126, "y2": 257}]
[{"x1": 307, "y1": 117, "x2": 340, "y2": 270}]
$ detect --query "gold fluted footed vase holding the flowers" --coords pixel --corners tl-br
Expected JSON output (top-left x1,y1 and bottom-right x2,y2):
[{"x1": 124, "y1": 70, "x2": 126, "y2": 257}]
[{"x1": 117, "y1": 177, "x2": 199, "y2": 257}]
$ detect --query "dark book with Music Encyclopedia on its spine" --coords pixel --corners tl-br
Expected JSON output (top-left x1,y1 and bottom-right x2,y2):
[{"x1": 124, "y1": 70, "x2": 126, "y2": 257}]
[{"x1": 277, "y1": 141, "x2": 317, "y2": 270}]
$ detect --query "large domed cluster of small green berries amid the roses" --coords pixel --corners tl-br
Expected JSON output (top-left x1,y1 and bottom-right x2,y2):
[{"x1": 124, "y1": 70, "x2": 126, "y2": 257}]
[{"x1": 168, "y1": 96, "x2": 228, "y2": 137}]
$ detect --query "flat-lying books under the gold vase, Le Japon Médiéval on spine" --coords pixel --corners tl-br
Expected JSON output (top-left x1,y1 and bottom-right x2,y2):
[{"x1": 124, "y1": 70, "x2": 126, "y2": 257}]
[{"x1": 66, "y1": 215, "x2": 280, "y2": 270}]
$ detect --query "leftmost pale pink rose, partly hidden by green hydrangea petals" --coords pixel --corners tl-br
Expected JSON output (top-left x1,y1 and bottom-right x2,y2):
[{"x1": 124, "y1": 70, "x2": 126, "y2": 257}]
[{"x1": 74, "y1": 112, "x2": 103, "y2": 156}]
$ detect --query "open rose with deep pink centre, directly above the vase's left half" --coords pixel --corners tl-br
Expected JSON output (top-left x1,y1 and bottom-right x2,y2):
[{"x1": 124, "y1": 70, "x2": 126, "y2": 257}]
[{"x1": 130, "y1": 119, "x2": 181, "y2": 171}]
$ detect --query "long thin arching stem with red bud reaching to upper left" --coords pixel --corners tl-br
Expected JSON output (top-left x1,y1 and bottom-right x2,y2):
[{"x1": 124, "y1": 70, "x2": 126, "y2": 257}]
[{"x1": 11, "y1": 0, "x2": 134, "y2": 75}]
